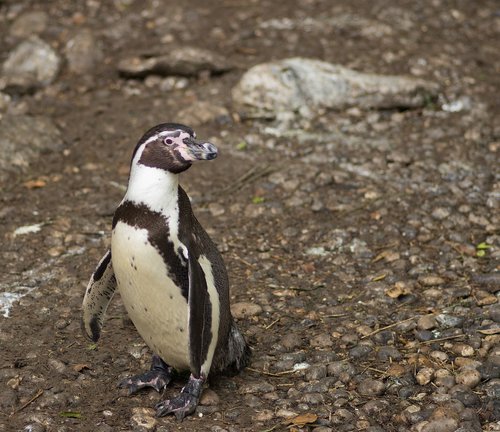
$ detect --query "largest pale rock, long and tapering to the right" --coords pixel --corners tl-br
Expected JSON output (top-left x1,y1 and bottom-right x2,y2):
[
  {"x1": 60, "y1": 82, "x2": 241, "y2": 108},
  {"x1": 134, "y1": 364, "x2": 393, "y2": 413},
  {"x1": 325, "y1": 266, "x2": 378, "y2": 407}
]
[{"x1": 232, "y1": 57, "x2": 437, "y2": 120}]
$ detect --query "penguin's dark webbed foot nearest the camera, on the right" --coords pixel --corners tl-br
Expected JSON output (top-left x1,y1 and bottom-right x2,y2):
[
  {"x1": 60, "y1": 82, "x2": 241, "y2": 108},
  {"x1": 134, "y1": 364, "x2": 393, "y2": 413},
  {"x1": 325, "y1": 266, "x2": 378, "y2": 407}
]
[{"x1": 156, "y1": 375, "x2": 205, "y2": 420}]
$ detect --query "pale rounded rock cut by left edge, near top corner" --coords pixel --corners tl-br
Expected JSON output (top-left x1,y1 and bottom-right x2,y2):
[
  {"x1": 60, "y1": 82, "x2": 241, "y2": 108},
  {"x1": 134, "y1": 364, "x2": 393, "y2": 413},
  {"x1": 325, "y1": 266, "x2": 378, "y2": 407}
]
[{"x1": 2, "y1": 36, "x2": 61, "y2": 93}]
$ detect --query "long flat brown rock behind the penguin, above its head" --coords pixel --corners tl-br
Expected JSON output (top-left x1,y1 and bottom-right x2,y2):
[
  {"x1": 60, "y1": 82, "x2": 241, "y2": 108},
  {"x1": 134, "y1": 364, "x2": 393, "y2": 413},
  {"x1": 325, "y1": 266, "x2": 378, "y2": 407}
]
[{"x1": 118, "y1": 47, "x2": 230, "y2": 78}]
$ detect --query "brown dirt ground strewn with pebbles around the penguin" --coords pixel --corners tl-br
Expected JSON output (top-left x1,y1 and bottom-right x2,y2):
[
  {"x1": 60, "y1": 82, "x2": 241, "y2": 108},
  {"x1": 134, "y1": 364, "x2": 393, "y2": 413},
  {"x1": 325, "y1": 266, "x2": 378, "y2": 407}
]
[{"x1": 0, "y1": 0, "x2": 500, "y2": 432}]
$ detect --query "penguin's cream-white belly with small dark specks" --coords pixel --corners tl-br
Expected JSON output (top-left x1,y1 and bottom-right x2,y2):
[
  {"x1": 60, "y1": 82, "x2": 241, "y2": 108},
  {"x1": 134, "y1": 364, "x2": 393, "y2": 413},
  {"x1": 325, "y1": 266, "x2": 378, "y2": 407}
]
[{"x1": 111, "y1": 222, "x2": 190, "y2": 369}]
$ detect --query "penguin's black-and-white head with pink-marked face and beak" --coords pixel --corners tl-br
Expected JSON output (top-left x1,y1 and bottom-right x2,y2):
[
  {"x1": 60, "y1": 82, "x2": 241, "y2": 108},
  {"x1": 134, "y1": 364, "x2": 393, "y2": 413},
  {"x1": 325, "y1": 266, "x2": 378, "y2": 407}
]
[{"x1": 132, "y1": 123, "x2": 217, "y2": 174}]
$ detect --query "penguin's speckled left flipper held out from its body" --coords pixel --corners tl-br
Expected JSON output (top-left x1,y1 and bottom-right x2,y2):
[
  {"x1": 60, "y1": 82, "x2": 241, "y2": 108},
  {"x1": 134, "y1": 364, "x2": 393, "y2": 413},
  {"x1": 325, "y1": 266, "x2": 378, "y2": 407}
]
[{"x1": 82, "y1": 249, "x2": 116, "y2": 342}]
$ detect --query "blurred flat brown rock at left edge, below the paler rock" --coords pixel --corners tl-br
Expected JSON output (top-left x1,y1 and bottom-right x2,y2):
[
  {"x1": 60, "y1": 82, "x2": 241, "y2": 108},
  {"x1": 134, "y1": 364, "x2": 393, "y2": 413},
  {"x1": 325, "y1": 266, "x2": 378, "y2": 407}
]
[{"x1": 0, "y1": 115, "x2": 63, "y2": 181}]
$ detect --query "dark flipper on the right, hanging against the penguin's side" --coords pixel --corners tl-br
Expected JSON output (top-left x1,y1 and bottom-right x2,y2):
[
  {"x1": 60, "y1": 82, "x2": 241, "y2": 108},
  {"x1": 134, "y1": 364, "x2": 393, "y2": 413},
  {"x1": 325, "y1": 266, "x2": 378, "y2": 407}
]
[{"x1": 188, "y1": 251, "x2": 212, "y2": 378}]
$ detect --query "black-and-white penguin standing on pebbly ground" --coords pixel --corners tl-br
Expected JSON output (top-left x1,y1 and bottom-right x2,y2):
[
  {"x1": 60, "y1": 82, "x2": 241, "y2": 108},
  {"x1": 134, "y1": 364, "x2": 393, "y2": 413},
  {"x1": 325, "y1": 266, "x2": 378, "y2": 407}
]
[{"x1": 82, "y1": 123, "x2": 251, "y2": 420}]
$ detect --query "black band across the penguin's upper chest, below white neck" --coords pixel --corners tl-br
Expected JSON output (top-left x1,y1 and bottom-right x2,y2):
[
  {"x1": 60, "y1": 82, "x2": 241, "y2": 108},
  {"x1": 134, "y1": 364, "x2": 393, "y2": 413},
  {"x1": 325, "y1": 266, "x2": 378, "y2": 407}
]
[{"x1": 113, "y1": 201, "x2": 189, "y2": 300}]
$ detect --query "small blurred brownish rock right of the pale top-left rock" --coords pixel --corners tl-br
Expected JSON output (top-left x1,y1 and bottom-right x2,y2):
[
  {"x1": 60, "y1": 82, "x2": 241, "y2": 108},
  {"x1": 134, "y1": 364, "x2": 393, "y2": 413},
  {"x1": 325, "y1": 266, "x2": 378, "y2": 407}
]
[{"x1": 64, "y1": 29, "x2": 104, "y2": 74}]
